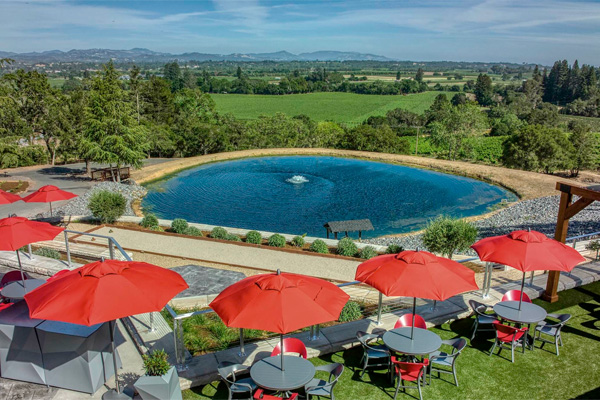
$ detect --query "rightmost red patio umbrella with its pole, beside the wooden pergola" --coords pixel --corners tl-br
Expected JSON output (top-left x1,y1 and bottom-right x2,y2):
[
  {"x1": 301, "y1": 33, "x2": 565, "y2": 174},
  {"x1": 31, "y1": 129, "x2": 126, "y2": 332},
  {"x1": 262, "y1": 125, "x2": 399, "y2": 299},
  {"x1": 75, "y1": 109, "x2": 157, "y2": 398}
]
[{"x1": 471, "y1": 230, "x2": 585, "y2": 310}]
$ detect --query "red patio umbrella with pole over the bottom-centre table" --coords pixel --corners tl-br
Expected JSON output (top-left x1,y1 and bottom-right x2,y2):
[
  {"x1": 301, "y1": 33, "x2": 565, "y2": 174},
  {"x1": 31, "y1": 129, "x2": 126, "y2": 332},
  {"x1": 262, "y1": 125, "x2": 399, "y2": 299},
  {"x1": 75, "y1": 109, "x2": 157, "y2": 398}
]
[{"x1": 210, "y1": 270, "x2": 350, "y2": 370}]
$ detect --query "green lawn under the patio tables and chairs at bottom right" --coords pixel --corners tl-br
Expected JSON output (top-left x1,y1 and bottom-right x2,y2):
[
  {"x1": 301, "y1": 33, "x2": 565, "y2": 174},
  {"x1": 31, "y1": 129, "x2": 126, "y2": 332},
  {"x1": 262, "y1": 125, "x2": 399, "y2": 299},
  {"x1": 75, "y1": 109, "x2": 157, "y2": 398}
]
[{"x1": 184, "y1": 282, "x2": 600, "y2": 400}]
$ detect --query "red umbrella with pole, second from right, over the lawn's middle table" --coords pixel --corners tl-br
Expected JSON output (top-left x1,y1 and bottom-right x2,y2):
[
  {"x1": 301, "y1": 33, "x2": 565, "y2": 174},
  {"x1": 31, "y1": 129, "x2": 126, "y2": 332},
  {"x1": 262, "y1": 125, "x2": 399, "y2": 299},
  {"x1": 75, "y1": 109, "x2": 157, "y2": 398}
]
[{"x1": 354, "y1": 250, "x2": 479, "y2": 338}]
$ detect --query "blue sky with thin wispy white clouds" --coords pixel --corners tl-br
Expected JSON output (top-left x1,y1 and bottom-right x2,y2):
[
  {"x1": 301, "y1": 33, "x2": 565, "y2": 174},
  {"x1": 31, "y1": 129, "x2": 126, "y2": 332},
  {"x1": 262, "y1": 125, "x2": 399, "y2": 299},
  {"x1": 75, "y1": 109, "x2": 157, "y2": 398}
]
[{"x1": 0, "y1": 0, "x2": 600, "y2": 65}]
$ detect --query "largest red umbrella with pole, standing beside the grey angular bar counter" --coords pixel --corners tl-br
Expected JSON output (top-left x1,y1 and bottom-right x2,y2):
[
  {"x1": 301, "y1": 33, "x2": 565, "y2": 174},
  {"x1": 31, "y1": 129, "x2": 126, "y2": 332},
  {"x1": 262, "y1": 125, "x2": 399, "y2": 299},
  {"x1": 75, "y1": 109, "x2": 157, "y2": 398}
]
[{"x1": 25, "y1": 260, "x2": 188, "y2": 393}]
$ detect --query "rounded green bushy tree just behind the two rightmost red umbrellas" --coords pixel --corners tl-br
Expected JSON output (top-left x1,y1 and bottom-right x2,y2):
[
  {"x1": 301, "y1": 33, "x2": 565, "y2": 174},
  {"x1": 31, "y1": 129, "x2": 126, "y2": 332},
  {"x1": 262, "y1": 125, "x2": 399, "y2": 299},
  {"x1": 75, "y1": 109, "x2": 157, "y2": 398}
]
[{"x1": 421, "y1": 215, "x2": 477, "y2": 258}]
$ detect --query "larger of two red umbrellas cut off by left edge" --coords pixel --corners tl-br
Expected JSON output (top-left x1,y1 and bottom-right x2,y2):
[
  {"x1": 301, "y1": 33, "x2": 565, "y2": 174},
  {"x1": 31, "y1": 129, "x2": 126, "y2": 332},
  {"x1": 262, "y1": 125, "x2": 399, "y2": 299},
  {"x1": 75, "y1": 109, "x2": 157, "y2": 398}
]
[{"x1": 0, "y1": 217, "x2": 65, "y2": 287}]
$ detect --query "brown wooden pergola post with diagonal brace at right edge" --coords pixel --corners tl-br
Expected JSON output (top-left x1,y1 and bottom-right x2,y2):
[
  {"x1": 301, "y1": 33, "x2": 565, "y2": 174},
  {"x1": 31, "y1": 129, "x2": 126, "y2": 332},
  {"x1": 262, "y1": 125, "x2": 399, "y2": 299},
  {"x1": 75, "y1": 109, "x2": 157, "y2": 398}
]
[{"x1": 542, "y1": 182, "x2": 600, "y2": 303}]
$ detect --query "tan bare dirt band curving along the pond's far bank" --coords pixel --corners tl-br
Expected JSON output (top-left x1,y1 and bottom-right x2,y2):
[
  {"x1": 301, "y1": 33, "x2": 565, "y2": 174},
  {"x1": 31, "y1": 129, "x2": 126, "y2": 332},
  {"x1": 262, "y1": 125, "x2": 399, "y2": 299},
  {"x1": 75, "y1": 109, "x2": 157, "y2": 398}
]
[{"x1": 132, "y1": 149, "x2": 599, "y2": 200}]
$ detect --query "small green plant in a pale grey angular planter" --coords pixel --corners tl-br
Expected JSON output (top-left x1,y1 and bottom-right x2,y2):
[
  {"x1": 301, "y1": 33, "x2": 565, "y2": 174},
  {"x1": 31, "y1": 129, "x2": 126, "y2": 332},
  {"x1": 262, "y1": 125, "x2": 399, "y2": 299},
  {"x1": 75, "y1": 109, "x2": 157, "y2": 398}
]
[{"x1": 133, "y1": 349, "x2": 182, "y2": 400}]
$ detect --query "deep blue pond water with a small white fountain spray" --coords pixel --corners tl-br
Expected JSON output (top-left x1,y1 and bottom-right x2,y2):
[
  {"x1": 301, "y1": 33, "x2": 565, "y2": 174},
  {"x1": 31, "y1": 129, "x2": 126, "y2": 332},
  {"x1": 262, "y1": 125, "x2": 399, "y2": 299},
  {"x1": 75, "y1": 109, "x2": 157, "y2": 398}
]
[{"x1": 143, "y1": 156, "x2": 515, "y2": 237}]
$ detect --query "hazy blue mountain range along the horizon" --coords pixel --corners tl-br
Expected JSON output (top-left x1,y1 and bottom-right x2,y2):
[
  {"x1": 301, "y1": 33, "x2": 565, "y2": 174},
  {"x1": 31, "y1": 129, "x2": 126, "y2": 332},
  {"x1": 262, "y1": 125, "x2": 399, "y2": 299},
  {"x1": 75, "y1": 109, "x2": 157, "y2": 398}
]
[{"x1": 0, "y1": 48, "x2": 395, "y2": 62}]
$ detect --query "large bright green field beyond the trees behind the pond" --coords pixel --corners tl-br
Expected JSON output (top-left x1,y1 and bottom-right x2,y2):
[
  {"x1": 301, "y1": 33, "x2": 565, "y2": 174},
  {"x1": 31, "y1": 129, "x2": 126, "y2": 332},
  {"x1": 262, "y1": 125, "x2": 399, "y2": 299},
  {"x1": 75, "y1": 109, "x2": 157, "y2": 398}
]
[{"x1": 211, "y1": 92, "x2": 441, "y2": 123}]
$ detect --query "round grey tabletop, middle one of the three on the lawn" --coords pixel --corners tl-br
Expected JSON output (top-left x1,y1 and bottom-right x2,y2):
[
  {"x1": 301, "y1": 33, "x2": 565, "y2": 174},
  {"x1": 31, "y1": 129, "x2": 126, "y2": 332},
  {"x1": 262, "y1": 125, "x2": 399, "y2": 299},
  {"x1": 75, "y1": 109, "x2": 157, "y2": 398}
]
[{"x1": 383, "y1": 327, "x2": 442, "y2": 356}]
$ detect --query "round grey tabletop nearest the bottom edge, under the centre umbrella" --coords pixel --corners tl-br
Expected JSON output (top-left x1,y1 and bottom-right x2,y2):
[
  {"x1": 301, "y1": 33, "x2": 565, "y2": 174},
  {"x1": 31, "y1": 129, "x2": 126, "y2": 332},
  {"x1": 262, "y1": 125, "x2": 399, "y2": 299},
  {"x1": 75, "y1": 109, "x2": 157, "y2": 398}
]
[{"x1": 250, "y1": 356, "x2": 315, "y2": 392}]
